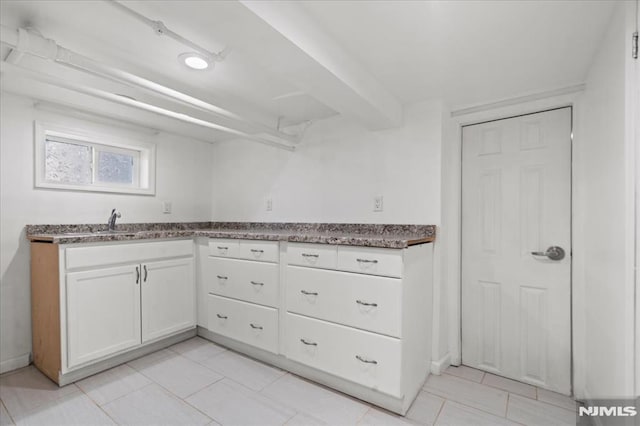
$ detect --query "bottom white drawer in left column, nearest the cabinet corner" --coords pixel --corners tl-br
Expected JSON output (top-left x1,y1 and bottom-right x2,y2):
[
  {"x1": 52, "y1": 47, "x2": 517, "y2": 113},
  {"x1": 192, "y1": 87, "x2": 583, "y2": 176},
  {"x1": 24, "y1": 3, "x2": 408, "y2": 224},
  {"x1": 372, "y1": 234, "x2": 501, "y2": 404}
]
[{"x1": 208, "y1": 294, "x2": 278, "y2": 352}]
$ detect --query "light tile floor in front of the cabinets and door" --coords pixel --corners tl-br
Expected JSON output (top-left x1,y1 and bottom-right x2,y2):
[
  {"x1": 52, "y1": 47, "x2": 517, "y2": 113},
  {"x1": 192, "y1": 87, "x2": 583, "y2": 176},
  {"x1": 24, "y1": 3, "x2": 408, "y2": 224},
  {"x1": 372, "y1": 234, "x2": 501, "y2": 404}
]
[{"x1": 0, "y1": 337, "x2": 575, "y2": 426}]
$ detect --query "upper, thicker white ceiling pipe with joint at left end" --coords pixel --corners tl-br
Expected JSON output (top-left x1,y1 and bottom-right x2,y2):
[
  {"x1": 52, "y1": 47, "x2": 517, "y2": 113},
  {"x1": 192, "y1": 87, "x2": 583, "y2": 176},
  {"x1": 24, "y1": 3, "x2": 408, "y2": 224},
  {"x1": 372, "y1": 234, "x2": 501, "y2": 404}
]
[{"x1": 0, "y1": 25, "x2": 299, "y2": 145}]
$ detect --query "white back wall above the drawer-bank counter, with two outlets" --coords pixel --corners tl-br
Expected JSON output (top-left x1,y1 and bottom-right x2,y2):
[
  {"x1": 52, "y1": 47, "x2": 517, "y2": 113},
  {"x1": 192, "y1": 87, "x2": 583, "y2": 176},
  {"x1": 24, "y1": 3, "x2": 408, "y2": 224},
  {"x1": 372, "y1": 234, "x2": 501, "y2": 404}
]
[{"x1": 213, "y1": 102, "x2": 442, "y2": 224}]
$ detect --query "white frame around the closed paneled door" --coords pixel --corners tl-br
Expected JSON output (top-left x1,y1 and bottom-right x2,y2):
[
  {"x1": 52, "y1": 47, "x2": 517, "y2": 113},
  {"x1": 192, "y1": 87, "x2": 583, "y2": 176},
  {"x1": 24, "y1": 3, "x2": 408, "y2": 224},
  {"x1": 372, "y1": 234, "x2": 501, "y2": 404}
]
[{"x1": 442, "y1": 85, "x2": 586, "y2": 399}]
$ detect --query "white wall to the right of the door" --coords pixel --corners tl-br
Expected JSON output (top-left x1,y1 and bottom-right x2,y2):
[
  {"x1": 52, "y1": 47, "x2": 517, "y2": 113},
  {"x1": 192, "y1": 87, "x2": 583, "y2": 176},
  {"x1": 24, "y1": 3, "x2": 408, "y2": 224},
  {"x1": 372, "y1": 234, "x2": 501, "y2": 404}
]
[{"x1": 574, "y1": 2, "x2": 637, "y2": 399}]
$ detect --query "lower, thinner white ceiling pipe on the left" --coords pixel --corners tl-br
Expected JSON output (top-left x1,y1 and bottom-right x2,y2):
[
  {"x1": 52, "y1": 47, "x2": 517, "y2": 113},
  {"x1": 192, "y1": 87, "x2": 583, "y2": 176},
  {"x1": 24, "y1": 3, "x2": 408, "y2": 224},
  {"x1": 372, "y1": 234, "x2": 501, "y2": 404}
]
[{"x1": 0, "y1": 62, "x2": 295, "y2": 151}]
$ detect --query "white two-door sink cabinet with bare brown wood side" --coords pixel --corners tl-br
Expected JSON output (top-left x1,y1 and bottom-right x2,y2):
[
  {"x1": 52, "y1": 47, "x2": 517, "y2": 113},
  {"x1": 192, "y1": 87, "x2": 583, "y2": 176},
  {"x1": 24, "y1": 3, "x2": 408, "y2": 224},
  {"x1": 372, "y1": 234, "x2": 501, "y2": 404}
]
[{"x1": 31, "y1": 240, "x2": 196, "y2": 383}]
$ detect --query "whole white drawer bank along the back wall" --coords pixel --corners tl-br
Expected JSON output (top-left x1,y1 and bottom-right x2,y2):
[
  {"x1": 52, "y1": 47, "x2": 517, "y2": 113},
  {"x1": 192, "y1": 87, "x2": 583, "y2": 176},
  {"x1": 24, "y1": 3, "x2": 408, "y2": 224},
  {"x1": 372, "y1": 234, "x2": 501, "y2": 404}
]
[{"x1": 204, "y1": 239, "x2": 433, "y2": 414}]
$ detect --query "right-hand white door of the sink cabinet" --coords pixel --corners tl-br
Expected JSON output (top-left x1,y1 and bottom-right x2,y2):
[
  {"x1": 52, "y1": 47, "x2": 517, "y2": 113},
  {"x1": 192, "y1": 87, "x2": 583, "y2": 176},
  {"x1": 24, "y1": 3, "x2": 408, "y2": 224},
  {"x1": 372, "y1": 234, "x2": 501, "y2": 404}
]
[{"x1": 142, "y1": 258, "x2": 196, "y2": 342}]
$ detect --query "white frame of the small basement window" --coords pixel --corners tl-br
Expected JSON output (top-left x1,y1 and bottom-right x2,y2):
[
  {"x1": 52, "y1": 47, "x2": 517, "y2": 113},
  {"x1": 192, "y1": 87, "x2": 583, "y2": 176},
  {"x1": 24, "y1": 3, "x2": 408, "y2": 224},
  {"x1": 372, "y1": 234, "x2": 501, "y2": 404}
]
[{"x1": 34, "y1": 121, "x2": 156, "y2": 195}]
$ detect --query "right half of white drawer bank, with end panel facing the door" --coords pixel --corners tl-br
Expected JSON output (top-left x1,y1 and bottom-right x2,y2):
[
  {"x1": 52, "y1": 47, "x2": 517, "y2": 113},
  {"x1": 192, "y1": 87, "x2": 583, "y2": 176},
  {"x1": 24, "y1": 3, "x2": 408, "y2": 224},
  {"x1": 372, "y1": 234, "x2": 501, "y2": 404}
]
[{"x1": 282, "y1": 244, "x2": 433, "y2": 414}]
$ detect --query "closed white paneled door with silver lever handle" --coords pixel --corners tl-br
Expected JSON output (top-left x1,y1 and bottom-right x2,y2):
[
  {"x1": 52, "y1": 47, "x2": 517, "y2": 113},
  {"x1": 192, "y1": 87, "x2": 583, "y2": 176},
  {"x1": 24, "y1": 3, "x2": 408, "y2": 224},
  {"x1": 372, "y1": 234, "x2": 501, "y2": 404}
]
[{"x1": 462, "y1": 108, "x2": 571, "y2": 394}]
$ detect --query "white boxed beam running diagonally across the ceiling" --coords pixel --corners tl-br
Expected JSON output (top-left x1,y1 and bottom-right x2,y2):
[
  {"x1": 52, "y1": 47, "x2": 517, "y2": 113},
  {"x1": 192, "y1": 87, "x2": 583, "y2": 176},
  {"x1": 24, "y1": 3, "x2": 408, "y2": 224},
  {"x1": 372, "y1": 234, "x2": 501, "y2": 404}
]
[{"x1": 240, "y1": 0, "x2": 402, "y2": 130}]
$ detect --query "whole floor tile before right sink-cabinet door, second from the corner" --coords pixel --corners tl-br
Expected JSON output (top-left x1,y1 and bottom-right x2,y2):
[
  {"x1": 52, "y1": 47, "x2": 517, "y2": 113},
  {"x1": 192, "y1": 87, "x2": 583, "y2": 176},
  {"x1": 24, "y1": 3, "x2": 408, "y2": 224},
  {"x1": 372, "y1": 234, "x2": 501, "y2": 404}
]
[{"x1": 130, "y1": 351, "x2": 222, "y2": 398}]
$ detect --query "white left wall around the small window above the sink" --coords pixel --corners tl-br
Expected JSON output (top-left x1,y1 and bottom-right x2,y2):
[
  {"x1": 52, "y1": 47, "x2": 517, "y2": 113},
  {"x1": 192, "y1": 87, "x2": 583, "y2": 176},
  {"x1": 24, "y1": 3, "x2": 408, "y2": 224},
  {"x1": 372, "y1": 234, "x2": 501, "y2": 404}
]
[{"x1": 0, "y1": 92, "x2": 213, "y2": 371}]
